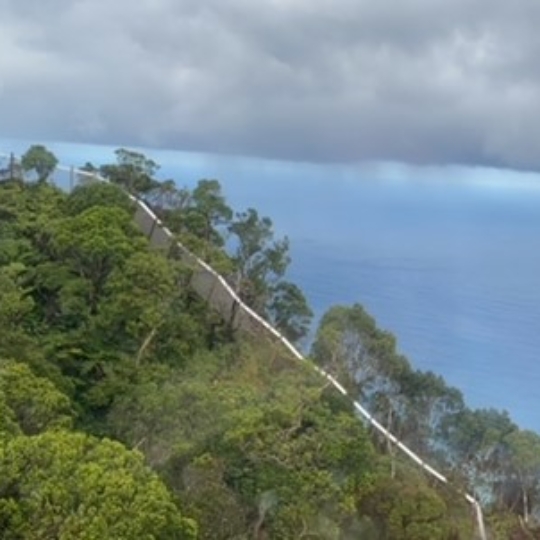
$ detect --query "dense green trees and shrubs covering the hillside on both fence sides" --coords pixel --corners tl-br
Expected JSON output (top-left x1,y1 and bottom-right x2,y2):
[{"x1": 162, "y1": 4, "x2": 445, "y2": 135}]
[{"x1": 0, "y1": 147, "x2": 540, "y2": 540}]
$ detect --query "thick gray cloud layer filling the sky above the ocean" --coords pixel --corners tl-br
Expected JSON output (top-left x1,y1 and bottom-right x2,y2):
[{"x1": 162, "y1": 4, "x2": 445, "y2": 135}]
[{"x1": 0, "y1": 0, "x2": 540, "y2": 168}]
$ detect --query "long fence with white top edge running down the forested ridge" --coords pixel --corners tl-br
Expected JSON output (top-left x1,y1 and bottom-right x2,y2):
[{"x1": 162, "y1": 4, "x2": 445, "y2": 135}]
[{"x1": 0, "y1": 154, "x2": 487, "y2": 540}]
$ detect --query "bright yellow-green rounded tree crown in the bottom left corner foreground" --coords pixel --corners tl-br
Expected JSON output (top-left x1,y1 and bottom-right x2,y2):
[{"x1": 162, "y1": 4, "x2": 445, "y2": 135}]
[{"x1": 0, "y1": 431, "x2": 196, "y2": 540}]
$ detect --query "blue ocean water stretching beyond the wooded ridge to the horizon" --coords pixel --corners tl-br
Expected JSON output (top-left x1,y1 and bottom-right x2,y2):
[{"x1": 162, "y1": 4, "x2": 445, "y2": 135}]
[{"x1": 3, "y1": 143, "x2": 540, "y2": 432}]
